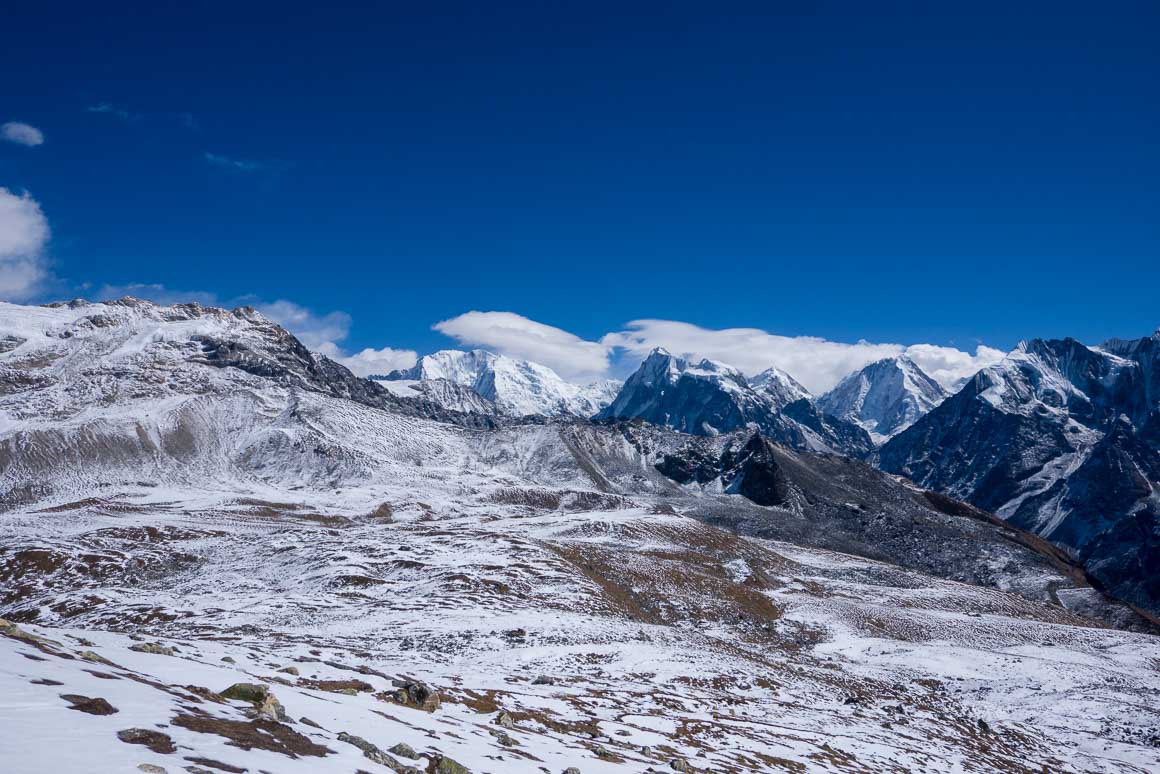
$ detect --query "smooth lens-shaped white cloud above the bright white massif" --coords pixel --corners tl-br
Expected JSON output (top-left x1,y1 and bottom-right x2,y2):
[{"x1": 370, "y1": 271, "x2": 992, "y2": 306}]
[{"x1": 432, "y1": 312, "x2": 610, "y2": 379}]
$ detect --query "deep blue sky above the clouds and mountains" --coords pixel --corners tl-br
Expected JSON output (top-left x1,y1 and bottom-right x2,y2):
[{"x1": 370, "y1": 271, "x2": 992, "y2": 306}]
[{"x1": 0, "y1": 2, "x2": 1160, "y2": 349}]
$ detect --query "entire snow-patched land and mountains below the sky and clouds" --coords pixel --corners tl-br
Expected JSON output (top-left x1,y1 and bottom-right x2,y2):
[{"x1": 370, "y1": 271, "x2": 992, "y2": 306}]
[{"x1": 0, "y1": 298, "x2": 1160, "y2": 774}]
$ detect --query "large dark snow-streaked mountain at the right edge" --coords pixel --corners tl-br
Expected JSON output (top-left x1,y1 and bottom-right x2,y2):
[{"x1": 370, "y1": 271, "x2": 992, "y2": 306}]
[{"x1": 879, "y1": 337, "x2": 1160, "y2": 610}]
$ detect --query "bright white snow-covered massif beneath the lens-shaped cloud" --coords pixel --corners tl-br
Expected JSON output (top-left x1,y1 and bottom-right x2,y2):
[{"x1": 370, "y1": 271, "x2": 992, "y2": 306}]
[{"x1": 374, "y1": 349, "x2": 619, "y2": 417}]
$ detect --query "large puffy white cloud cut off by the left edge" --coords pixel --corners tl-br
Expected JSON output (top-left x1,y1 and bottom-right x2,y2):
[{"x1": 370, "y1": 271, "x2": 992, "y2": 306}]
[{"x1": 0, "y1": 187, "x2": 51, "y2": 301}]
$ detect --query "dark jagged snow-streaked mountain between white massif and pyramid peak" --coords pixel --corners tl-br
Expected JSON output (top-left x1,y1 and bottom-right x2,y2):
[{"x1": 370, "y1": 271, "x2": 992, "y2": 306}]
[{"x1": 596, "y1": 348, "x2": 872, "y2": 455}]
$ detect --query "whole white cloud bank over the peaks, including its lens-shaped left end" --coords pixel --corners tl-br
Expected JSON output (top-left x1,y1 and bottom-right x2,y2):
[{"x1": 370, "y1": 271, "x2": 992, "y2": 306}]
[{"x1": 433, "y1": 311, "x2": 1005, "y2": 393}]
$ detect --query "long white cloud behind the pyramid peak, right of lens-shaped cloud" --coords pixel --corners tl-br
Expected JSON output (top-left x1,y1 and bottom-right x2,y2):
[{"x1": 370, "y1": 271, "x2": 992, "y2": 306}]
[{"x1": 601, "y1": 320, "x2": 1003, "y2": 395}]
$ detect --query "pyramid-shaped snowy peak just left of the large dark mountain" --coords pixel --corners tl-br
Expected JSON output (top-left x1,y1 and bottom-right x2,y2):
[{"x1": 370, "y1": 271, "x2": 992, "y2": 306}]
[{"x1": 818, "y1": 356, "x2": 947, "y2": 443}]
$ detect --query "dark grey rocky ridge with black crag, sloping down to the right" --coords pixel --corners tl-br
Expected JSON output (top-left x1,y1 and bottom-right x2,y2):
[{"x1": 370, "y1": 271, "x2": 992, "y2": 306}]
[{"x1": 640, "y1": 425, "x2": 1154, "y2": 631}]
